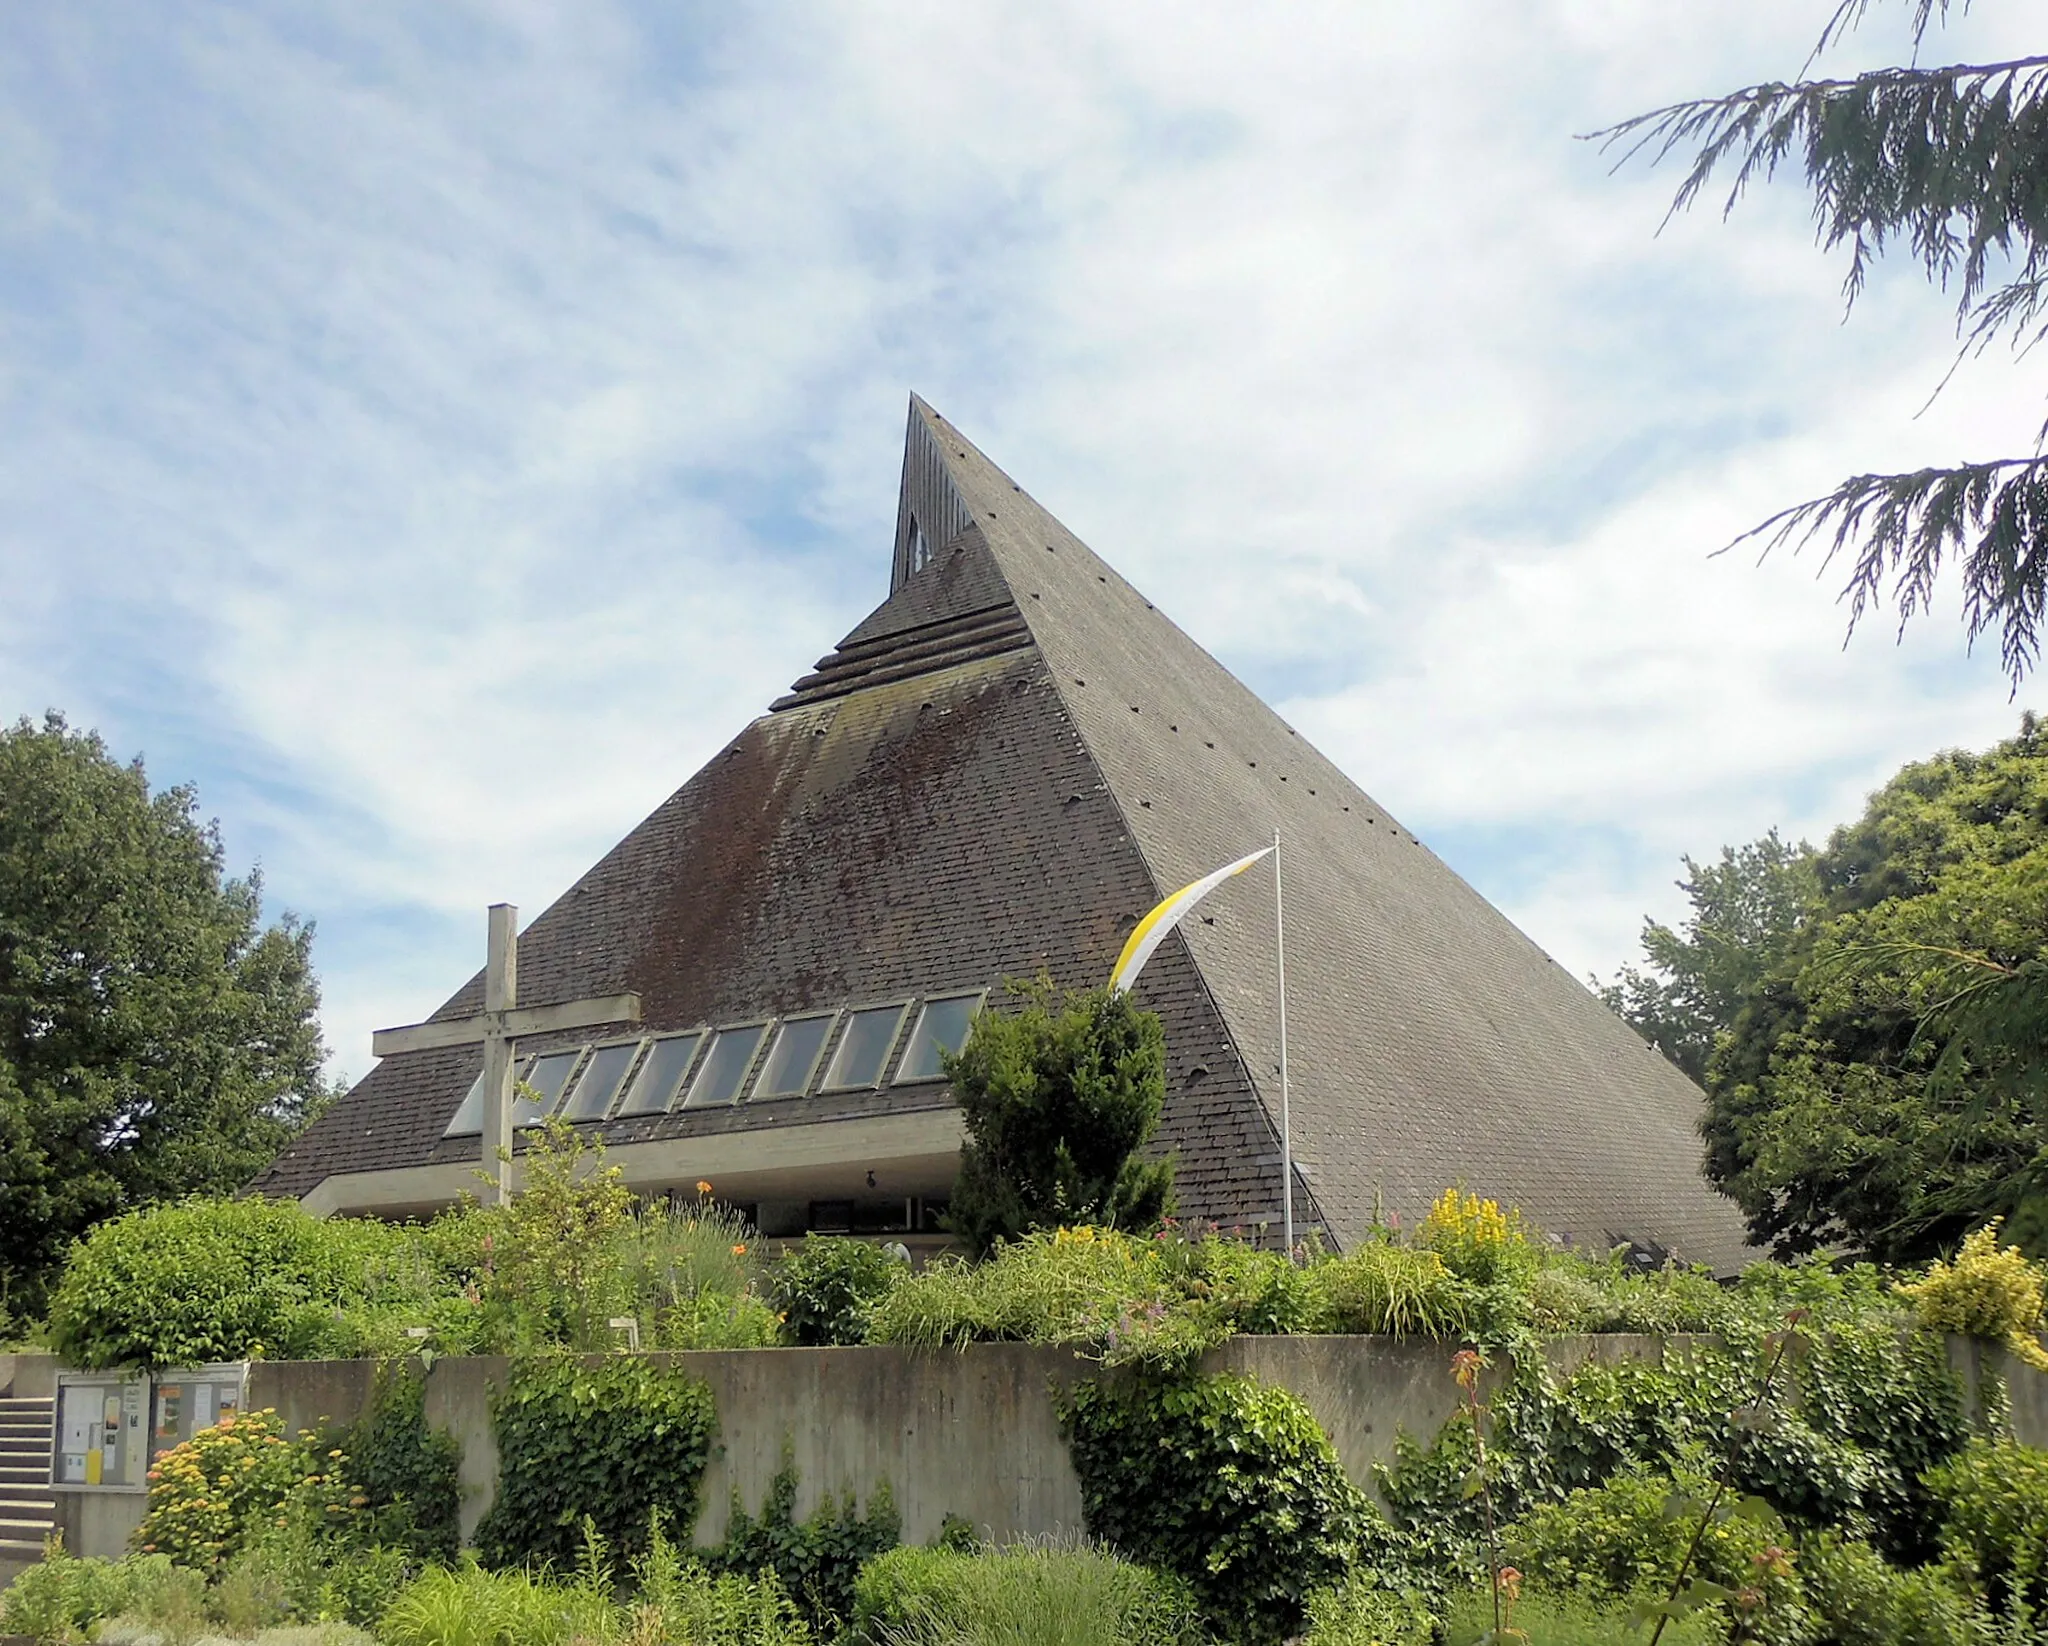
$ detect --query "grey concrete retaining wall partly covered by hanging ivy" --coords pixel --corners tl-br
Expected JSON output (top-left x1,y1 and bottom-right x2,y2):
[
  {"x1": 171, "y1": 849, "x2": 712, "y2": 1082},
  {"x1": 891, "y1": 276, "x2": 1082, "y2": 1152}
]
[{"x1": 0, "y1": 1335, "x2": 2048, "y2": 1556}]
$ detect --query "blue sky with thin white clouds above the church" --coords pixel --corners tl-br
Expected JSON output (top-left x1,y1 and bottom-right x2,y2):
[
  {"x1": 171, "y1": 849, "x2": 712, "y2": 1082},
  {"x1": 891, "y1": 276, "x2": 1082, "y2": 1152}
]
[{"x1": 0, "y1": 0, "x2": 2040, "y2": 1075}]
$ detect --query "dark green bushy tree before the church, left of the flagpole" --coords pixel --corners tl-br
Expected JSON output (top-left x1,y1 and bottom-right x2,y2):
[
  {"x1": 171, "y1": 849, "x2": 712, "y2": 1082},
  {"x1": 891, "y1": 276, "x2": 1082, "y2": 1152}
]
[{"x1": 944, "y1": 981, "x2": 1174, "y2": 1253}]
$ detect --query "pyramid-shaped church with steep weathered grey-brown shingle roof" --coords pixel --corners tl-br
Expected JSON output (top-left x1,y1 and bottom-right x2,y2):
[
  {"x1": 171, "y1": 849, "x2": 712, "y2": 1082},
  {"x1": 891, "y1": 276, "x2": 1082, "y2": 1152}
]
[{"x1": 254, "y1": 399, "x2": 1743, "y2": 1269}]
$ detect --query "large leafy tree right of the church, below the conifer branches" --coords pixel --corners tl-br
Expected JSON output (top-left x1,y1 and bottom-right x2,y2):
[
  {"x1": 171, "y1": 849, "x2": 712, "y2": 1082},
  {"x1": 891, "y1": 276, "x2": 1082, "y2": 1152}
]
[{"x1": 1620, "y1": 714, "x2": 2048, "y2": 1261}]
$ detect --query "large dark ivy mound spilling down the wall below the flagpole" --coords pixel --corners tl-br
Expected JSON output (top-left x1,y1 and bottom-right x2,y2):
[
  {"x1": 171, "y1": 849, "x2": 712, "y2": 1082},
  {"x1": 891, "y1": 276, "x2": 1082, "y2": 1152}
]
[{"x1": 1061, "y1": 1376, "x2": 1374, "y2": 1642}]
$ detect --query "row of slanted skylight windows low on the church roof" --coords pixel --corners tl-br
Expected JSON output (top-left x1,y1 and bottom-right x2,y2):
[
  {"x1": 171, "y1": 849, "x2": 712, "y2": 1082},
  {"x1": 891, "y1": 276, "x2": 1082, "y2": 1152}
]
[{"x1": 442, "y1": 991, "x2": 985, "y2": 1138}]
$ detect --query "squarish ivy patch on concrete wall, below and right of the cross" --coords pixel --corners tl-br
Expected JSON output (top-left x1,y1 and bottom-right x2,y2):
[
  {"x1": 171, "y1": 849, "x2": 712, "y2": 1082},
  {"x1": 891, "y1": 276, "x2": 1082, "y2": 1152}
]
[{"x1": 477, "y1": 1355, "x2": 717, "y2": 1566}]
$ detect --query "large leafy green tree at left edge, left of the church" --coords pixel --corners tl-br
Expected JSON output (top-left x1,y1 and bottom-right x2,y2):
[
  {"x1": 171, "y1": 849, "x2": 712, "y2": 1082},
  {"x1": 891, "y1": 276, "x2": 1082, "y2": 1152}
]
[{"x1": 0, "y1": 714, "x2": 328, "y2": 1308}]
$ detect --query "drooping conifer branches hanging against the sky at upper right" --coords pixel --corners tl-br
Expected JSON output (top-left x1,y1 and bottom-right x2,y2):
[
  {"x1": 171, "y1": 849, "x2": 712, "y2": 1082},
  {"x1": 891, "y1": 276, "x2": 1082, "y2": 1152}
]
[{"x1": 1593, "y1": 0, "x2": 2048, "y2": 686}]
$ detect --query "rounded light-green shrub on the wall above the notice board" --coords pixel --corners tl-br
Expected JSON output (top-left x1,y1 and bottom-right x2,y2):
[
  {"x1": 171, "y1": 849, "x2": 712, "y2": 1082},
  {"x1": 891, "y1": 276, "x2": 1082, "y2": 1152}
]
[{"x1": 49, "y1": 1198, "x2": 403, "y2": 1368}]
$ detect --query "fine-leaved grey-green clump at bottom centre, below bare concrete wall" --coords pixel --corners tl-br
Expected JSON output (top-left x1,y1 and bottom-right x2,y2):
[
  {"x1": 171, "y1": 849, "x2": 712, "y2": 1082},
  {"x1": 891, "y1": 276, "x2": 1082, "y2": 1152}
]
[{"x1": 852, "y1": 1544, "x2": 1200, "y2": 1646}]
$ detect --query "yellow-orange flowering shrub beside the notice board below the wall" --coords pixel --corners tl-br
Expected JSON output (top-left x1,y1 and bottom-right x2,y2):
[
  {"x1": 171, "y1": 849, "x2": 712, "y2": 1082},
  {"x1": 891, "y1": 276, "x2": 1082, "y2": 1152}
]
[{"x1": 131, "y1": 1409, "x2": 362, "y2": 1576}]
